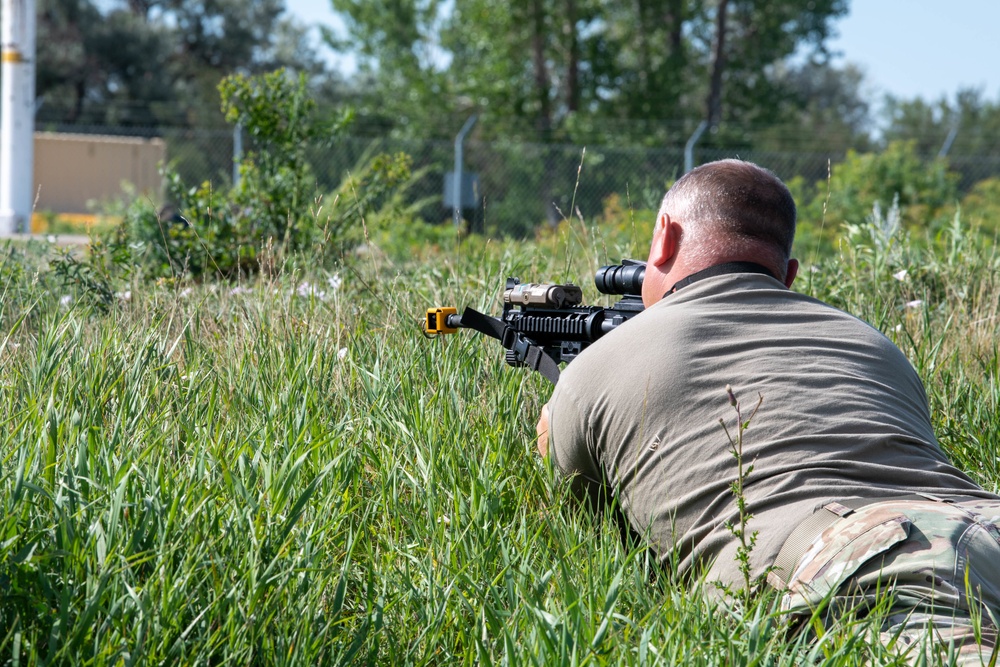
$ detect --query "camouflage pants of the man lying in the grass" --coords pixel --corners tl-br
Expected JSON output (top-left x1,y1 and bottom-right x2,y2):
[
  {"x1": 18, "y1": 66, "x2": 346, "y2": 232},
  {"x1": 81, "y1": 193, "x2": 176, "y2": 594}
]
[{"x1": 782, "y1": 500, "x2": 1000, "y2": 665}]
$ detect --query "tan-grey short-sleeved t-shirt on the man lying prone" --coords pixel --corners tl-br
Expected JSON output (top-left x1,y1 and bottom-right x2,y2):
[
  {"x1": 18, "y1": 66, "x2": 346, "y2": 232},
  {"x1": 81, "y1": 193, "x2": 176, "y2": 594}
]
[{"x1": 549, "y1": 274, "x2": 992, "y2": 585}]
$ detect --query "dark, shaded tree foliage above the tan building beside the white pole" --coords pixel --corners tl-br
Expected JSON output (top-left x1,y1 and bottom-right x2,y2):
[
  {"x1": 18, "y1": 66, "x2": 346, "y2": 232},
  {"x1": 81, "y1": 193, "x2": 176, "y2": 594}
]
[{"x1": 37, "y1": 0, "x2": 324, "y2": 127}]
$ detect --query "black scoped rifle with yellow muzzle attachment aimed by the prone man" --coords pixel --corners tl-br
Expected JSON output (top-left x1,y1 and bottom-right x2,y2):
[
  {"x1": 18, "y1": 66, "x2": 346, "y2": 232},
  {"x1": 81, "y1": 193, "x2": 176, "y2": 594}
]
[{"x1": 423, "y1": 259, "x2": 646, "y2": 384}]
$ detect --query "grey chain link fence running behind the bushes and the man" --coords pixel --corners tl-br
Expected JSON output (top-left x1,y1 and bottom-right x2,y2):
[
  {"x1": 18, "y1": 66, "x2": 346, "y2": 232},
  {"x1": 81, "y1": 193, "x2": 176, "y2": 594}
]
[{"x1": 50, "y1": 127, "x2": 1000, "y2": 236}]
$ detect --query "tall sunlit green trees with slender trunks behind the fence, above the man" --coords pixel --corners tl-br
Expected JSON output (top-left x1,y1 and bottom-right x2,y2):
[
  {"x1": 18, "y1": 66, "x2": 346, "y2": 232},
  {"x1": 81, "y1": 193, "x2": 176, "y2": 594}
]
[{"x1": 330, "y1": 0, "x2": 861, "y2": 145}]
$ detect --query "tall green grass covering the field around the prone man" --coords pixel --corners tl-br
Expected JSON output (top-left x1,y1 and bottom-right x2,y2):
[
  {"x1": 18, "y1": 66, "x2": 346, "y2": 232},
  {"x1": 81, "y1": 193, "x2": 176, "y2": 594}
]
[{"x1": 0, "y1": 211, "x2": 1000, "y2": 665}]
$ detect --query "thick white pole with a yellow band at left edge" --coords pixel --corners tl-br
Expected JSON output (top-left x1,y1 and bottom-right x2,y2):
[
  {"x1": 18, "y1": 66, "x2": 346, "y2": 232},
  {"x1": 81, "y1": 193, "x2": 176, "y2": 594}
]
[{"x1": 0, "y1": 0, "x2": 36, "y2": 236}]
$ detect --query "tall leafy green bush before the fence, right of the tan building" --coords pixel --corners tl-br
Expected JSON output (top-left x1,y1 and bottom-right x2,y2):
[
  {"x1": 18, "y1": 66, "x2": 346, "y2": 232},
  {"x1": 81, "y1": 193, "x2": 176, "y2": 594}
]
[{"x1": 96, "y1": 70, "x2": 412, "y2": 278}]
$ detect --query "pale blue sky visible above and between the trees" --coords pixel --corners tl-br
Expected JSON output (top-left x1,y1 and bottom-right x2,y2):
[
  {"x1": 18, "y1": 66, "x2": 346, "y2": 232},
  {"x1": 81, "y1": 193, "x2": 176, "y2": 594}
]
[{"x1": 286, "y1": 0, "x2": 1000, "y2": 101}]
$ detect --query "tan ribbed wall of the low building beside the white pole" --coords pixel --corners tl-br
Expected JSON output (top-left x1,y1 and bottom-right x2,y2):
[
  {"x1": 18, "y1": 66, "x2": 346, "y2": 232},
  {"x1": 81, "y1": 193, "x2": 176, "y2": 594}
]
[{"x1": 34, "y1": 132, "x2": 166, "y2": 213}]
